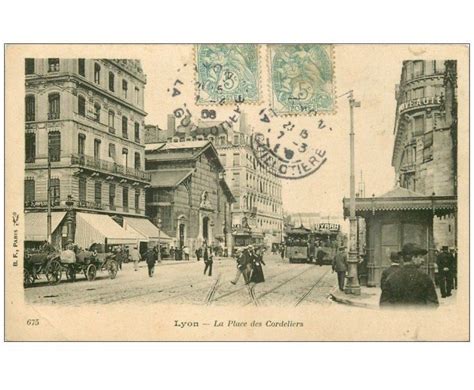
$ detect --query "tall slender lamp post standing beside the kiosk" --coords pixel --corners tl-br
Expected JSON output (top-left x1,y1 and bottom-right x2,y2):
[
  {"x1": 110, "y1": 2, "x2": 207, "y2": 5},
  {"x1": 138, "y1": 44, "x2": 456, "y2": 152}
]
[{"x1": 344, "y1": 91, "x2": 360, "y2": 295}]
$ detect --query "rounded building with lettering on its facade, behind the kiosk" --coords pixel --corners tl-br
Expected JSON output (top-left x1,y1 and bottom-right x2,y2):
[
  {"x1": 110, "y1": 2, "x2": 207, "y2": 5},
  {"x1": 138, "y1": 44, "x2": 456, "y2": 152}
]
[{"x1": 392, "y1": 61, "x2": 457, "y2": 248}]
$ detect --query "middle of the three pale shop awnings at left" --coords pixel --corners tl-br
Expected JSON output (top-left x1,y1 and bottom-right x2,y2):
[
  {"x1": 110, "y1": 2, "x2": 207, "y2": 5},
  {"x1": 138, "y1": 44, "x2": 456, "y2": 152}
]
[{"x1": 75, "y1": 213, "x2": 140, "y2": 248}]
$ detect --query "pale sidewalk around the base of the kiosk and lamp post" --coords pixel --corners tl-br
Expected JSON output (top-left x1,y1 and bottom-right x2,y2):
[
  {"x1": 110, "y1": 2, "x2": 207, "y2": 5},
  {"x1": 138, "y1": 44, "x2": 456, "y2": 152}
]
[{"x1": 329, "y1": 286, "x2": 456, "y2": 309}]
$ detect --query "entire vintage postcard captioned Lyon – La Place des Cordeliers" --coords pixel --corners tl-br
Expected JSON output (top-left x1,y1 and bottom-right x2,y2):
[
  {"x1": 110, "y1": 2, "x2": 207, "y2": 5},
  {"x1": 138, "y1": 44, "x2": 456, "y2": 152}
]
[{"x1": 4, "y1": 43, "x2": 469, "y2": 341}]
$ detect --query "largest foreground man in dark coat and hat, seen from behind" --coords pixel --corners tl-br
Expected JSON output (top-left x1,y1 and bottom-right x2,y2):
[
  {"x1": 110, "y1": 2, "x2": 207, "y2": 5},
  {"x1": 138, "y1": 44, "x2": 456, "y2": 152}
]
[{"x1": 380, "y1": 243, "x2": 439, "y2": 307}]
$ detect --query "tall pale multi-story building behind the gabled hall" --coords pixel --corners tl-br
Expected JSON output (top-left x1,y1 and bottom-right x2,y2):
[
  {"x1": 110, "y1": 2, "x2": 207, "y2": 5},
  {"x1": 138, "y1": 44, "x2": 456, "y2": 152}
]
[{"x1": 146, "y1": 113, "x2": 283, "y2": 244}]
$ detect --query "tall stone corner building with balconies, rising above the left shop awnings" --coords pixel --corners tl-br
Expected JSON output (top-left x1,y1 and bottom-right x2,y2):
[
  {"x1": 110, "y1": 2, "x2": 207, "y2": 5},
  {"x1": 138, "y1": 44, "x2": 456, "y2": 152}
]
[{"x1": 25, "y1": 58, "x2": 156, "y2": 250}]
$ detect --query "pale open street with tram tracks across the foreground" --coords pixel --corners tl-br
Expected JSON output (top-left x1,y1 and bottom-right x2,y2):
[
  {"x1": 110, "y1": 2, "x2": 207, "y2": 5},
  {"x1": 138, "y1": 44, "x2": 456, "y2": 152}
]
[{"x1": 25, "y1": 254, "x2": 337, "y2": 306}]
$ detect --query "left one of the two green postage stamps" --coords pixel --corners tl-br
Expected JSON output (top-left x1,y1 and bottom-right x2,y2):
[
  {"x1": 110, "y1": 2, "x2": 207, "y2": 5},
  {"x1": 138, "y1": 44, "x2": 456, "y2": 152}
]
[{"x1": 196, "y1": 44, "x2": 260, "y2": 104}]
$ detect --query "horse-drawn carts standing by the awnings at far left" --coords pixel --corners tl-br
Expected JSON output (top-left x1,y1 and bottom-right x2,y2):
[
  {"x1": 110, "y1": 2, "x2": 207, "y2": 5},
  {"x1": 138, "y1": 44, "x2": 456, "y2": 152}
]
[{"x1": 23, "y1": 244, "x2": 118, "y2": 287}]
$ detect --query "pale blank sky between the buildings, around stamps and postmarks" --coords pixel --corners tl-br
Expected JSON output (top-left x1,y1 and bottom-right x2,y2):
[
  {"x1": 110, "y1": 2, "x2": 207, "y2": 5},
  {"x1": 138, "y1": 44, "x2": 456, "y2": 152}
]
[{"x1": 141, "y1": 45, "x2": 456, "y2": 219}]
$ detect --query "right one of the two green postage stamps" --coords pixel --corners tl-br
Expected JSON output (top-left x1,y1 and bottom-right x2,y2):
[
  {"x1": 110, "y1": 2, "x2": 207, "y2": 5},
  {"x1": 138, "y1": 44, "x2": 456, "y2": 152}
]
[{"x1": 268, "y1": 44, "x2": 335, "y2": 114}]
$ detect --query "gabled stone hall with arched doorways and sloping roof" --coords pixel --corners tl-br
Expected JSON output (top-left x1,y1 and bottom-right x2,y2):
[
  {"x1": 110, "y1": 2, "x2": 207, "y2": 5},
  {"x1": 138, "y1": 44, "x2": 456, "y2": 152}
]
[{"x1": 146, "y1": 141, "x2": 235, "y2": 256}]
